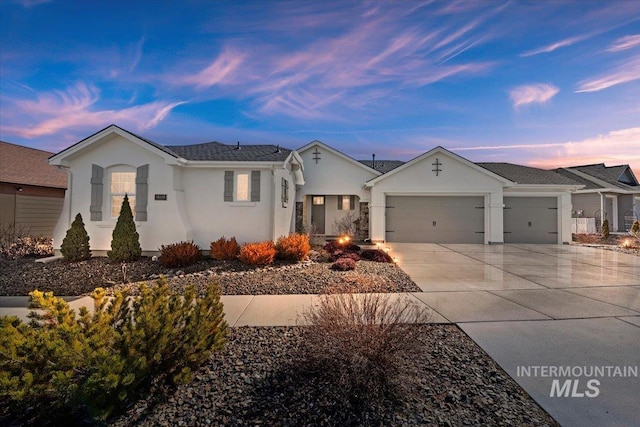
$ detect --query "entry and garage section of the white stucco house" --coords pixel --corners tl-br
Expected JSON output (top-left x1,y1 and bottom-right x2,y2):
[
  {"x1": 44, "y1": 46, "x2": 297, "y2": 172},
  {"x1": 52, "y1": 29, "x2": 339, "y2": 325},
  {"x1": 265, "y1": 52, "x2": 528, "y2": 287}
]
[{"x1": 296, "y1": 141, "x2": 582, "y2": 244}]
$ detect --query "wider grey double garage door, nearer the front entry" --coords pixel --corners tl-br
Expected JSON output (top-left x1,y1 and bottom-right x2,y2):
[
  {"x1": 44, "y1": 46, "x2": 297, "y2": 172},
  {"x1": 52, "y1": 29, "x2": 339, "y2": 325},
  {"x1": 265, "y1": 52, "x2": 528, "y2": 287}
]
[{"x1": 386, "y1": 196, "x2": 484, "y2": 243}]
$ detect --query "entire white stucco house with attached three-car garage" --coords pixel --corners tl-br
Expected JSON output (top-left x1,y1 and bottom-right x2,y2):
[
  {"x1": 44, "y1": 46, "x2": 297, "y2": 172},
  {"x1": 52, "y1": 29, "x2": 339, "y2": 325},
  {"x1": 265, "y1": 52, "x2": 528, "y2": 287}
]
[{"x1": 49, "y1": 125, "x2": 584, "y2": 255}]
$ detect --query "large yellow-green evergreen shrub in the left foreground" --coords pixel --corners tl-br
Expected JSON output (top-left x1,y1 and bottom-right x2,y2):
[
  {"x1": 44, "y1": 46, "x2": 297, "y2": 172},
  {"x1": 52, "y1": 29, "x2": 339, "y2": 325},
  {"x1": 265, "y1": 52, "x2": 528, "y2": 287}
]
[{"x1": 0, "y1": 281, "x2": 227, "y2": 425}]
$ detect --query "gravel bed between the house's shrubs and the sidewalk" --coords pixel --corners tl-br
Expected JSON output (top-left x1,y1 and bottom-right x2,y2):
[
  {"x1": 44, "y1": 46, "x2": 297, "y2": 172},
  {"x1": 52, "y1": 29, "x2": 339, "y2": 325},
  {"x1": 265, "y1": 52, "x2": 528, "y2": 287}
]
[{"x1": 0, "y1": 257, "x2": 420, "y2": 296}]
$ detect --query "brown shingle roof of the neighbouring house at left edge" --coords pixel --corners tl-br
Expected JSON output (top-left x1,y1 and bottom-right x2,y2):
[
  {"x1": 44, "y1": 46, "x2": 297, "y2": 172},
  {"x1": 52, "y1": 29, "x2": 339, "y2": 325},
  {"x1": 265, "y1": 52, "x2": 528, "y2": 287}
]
[{"x1": 0, "y1": 141, "x2": 67, "y2": 188}]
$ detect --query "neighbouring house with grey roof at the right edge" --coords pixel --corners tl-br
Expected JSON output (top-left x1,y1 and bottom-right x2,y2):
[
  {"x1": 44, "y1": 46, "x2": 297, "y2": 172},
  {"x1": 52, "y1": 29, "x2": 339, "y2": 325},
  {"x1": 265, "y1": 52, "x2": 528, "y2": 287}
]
[{"x1": 556, "y1": 163, "x2": 640, "y2": 232}]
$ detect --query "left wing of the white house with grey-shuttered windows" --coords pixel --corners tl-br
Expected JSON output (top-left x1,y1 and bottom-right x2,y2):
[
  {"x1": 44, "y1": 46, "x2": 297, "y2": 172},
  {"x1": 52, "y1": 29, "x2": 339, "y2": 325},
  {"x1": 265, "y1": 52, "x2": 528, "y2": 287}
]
[{"x1": 49, "y1": 125, "x2": 304, "y2": 255}]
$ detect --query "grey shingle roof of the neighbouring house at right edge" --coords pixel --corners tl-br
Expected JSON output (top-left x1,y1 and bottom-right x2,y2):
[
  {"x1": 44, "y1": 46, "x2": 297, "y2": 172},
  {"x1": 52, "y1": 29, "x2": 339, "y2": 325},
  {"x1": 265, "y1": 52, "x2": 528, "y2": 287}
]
[{"x1": 556, "y1": 163, "x2": 640, "y2": 192}]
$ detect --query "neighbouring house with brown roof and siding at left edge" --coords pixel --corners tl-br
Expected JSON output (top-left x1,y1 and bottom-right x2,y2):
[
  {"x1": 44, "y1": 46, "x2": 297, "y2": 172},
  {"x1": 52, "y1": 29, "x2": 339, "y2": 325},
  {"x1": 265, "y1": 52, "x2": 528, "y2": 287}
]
[{"x1": 0, "y1": 141, "x2": 67, "y2": 237}]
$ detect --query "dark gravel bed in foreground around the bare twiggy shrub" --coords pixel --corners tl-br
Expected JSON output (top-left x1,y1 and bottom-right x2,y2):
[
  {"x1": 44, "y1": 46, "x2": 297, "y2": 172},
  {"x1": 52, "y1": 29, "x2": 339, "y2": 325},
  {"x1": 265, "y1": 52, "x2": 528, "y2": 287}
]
[{"x1": 111, "y1": 325, "x2": 558, "y2": 427}]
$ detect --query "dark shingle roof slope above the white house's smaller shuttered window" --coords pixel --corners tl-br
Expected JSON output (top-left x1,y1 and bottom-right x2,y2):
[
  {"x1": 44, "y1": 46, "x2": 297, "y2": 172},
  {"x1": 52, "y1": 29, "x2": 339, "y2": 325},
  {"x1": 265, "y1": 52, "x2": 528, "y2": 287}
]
[{"x1": 167, "y1": 142, "x2": 291, "y2": 162}]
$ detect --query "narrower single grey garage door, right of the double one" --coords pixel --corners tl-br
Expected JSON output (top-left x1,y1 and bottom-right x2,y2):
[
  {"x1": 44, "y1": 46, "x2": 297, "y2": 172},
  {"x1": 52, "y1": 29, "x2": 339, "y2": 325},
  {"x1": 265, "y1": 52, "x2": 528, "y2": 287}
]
[{"x1": 504, "y1": 197, "x2": 558, "y2": 243}]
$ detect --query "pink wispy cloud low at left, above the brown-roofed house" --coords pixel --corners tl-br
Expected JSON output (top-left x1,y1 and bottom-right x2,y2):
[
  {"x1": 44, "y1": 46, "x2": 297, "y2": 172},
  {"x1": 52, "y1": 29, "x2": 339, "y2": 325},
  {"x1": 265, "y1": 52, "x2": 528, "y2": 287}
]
[{"x1": 0, "y1": 83, "x2": 184, "y2": 138}]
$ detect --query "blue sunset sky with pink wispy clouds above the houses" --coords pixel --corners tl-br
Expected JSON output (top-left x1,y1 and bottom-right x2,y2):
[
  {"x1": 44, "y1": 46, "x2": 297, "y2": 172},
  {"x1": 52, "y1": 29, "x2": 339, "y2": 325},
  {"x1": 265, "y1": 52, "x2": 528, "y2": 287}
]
[{"x1": 0, "y1": 0, "x2": 640, "y2": 173}]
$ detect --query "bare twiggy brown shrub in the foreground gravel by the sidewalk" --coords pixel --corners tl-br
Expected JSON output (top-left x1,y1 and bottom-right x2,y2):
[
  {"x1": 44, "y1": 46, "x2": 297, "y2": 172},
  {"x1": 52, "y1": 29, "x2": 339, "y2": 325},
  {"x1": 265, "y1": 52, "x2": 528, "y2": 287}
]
[{"x1": 299, "y1": 289, "x2": 430, "y2": 418}]
